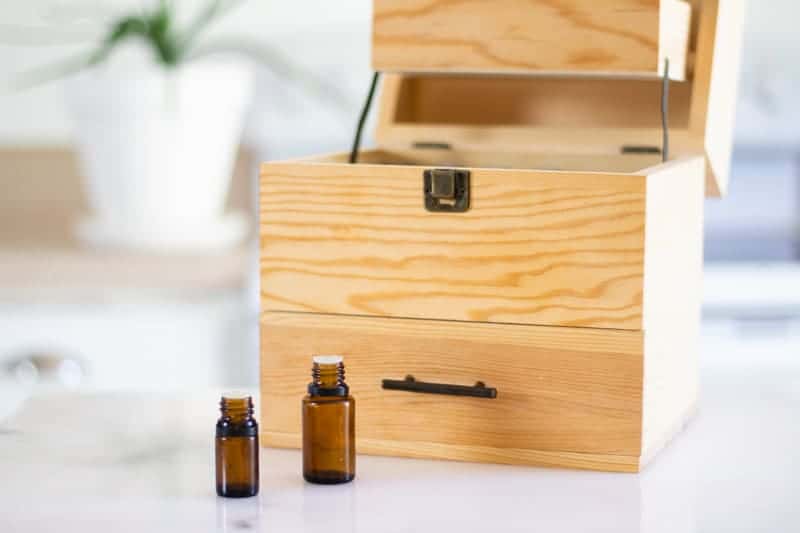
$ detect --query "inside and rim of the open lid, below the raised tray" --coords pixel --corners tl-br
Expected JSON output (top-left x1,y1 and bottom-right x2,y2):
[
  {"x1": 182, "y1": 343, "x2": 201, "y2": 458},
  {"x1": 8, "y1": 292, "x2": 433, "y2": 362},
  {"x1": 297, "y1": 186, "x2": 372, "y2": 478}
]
[{"x1": 376, "y1": 0, "x2": 714, "y2": 156}]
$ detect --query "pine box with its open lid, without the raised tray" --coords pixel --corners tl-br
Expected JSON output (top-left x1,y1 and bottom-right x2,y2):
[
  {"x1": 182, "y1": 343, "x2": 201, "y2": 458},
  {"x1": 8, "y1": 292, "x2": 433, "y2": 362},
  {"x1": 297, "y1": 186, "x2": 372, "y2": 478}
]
[{"x1": 260, "y1": 0, "x2": 741, "y2": 471}]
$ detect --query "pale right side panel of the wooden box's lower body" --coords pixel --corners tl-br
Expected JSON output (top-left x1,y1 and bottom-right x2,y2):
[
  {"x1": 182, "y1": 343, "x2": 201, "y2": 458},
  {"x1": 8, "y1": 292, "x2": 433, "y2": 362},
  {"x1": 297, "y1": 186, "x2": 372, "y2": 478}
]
[{"x1": 642, "y1": 157, "x2": 705, "y2": 458}]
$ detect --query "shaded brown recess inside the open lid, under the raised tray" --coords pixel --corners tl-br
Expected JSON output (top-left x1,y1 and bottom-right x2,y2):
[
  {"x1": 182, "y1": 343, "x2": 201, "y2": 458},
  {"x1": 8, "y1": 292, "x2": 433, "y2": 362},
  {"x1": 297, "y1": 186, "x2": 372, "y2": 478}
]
[{"x1": 393, "y1": 75, "x2": 692, "y2": 130}]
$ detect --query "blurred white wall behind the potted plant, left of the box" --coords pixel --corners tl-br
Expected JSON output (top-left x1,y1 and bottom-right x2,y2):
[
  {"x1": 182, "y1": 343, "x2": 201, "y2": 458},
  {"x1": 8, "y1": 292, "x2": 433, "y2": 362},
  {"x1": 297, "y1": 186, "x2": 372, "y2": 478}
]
[{"x1": 0, "y1": 0, "x2": 371, "y2": 153}]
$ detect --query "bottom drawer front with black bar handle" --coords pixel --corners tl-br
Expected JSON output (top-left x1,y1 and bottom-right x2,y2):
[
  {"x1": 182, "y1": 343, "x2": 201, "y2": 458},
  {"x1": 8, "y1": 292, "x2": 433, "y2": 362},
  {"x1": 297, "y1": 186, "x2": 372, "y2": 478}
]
[{"x1": 261, "y1": 313, "x2": 642, "y2": 463}]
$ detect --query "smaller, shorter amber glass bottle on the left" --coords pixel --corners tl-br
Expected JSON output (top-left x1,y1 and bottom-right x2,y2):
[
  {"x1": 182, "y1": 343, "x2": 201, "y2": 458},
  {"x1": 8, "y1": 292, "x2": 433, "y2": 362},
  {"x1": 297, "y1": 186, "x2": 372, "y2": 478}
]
[{"x1": 216, "y1": 396, "x2": 258, "y2": 498}]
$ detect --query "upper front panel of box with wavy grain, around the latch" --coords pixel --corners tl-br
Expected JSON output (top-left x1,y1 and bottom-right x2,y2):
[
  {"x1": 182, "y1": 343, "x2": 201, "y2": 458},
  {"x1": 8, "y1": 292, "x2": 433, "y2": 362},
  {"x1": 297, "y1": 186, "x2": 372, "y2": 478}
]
[{"x1": 260, "y1": 154, "x2": 645, "y2": 330}]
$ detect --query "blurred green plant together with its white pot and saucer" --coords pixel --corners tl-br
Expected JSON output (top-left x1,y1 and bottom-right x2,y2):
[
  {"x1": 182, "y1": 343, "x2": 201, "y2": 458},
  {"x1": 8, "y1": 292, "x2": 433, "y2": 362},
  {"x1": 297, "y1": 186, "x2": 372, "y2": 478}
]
[{"x1": 25, "y1": 0, "x2": 336, "y2": 251}]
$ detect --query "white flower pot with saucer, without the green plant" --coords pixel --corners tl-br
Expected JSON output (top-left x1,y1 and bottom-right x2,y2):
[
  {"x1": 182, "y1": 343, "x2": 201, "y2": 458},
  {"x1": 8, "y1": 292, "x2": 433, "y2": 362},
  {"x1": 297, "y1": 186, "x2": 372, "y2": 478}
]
[{"x1": 67, "y1": 53, "x2": 253, "y2": 251}]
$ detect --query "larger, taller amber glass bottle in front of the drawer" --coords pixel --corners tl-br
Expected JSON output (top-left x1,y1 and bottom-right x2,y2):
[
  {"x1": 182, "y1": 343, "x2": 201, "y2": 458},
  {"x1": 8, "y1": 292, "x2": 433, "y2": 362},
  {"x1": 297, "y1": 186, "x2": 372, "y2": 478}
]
[{"x1": 303, "y1": 355, "x2": 356, "y2": 484}]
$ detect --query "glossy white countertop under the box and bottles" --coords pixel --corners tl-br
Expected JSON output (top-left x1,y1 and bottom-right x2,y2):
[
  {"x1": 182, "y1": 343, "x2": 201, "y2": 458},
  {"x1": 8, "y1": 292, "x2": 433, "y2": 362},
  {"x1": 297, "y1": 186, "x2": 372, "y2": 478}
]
[{"x1": 0, "y1": 338, "x2": 800, "y2": 533}]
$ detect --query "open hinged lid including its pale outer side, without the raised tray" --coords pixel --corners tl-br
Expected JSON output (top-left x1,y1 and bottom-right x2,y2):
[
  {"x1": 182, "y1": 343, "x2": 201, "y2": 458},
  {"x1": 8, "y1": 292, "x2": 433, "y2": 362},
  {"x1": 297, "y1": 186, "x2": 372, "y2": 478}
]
[{"x1": 376, "y1": 0, "x2": 744, "y2": 196}]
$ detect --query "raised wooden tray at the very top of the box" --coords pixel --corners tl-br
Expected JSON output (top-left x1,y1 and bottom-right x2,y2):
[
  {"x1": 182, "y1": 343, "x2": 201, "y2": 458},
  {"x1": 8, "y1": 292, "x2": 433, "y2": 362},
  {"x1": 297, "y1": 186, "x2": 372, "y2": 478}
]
[{"x1": 372, "y1": 0, "x2": 690, "y2": 79}]
